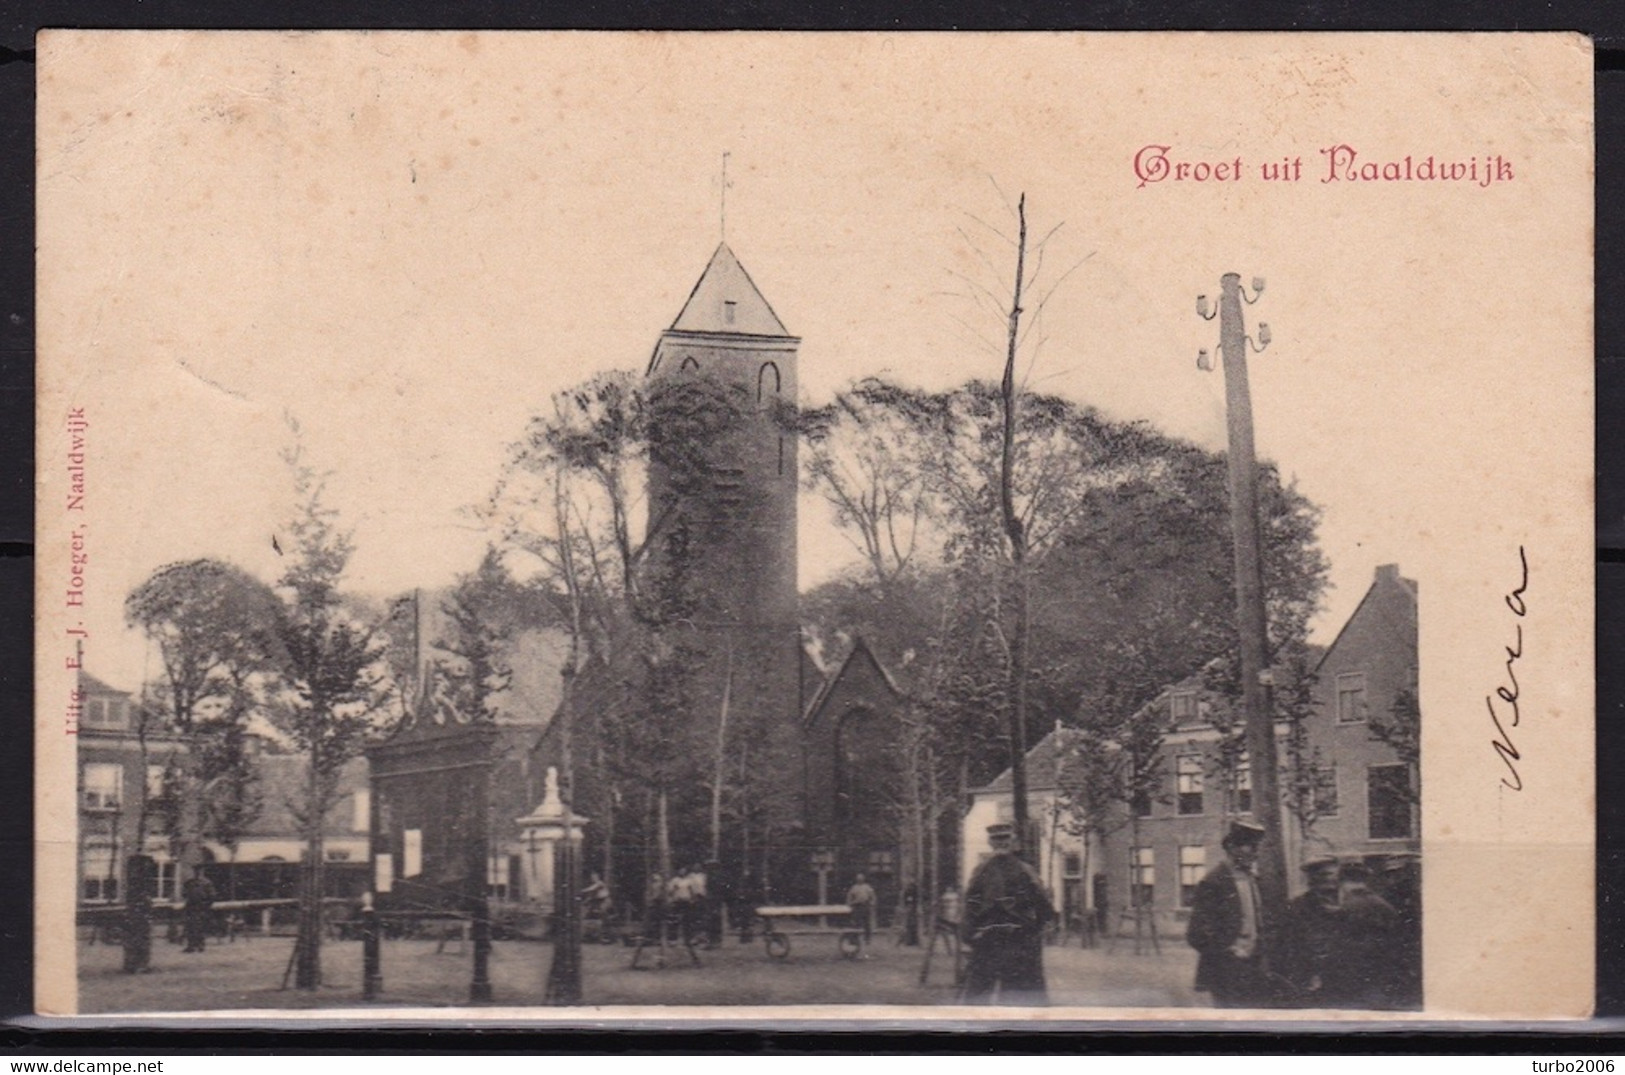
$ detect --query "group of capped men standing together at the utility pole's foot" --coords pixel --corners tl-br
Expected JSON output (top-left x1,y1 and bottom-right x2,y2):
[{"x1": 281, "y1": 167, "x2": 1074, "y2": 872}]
[{"x1": 1186, "y1": 822, "x2": 1422, "y2": 1008}]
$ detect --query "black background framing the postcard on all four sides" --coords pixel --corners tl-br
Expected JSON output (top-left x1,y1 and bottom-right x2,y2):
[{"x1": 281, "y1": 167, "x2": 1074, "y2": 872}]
[{"x1": 0, "y1": 0, "x2": 1625, "y2": 1057}]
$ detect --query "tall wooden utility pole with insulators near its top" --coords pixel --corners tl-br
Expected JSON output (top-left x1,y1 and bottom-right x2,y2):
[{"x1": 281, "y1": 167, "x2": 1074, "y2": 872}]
[{"x1": 1196, "y1": 273, "x2": 1287, "y2": 953}]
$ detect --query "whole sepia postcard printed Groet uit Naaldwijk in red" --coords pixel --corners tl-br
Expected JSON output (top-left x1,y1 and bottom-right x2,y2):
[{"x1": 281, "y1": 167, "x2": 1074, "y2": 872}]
[{"x1": 36, "y1": 31, "x2": 1594, "y2": 1025}]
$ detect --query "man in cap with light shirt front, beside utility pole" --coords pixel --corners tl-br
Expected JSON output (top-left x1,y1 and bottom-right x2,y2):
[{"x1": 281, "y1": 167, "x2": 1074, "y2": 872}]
[{"x1": 1185, "y1": 822, "x2": 1272, "y2": 1008}]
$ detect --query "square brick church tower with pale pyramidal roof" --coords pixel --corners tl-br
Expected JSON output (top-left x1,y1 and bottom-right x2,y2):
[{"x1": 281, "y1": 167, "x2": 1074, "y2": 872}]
[{"x1": 648, "y1": 244, "x2": 801, "y2": 824}]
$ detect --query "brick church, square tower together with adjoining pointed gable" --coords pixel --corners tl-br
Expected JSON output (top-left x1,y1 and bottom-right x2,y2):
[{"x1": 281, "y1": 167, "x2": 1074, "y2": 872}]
[{"x1": 624, "y1": 244, "x2": 905, "y2": 911}]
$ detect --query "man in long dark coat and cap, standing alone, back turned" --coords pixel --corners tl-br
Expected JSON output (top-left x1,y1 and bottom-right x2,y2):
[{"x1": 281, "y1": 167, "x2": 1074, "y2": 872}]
[{"x1": 964, "y1": 823, "x2": 1055, "y2": 1004}]
